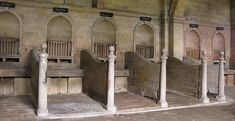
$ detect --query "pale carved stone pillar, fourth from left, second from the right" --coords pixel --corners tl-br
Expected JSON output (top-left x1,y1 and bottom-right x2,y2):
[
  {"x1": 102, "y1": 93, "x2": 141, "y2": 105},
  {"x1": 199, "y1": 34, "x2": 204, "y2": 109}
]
[{"x1": 201, "y1": 51, "x2": 210, "y2": 103}]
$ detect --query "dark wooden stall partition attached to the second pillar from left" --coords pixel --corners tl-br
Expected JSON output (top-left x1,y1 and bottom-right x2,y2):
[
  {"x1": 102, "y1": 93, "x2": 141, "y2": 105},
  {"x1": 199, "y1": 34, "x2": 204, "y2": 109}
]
[{"x1": 81, "y1": 50, "x2": 108, "y2": 105}]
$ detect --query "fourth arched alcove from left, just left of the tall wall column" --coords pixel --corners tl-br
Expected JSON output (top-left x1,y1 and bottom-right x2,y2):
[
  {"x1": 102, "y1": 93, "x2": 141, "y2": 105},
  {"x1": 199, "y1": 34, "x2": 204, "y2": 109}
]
[{"x1": 134, "y1": 24, "x2": 154, "y2": 58}]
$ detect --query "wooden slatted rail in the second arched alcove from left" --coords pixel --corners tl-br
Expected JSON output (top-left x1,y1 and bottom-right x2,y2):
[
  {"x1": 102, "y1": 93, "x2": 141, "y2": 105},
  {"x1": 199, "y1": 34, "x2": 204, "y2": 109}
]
[{"x1": 47, "y1": 40, "x2": 72, "y2": 57}]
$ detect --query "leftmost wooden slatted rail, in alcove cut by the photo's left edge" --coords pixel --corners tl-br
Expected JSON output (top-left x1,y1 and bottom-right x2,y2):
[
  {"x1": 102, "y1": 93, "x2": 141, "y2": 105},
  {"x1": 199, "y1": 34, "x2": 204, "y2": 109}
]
[{"x1": 0, "y1": 38, "x2": 19, "y2": 55}]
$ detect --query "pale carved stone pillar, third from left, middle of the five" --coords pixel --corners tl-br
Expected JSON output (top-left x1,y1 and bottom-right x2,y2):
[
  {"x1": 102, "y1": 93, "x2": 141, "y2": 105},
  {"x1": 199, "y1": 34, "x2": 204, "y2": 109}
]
[{"x1": 159, "y1": 49, "x2": 168, "y2": 108}]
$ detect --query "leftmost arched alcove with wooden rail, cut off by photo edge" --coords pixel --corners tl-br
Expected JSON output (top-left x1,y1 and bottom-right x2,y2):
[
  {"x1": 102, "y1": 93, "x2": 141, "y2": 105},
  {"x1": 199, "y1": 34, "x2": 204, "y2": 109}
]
[{"x1": 0, "y1": 11, "x2": 20, "y2": 62}]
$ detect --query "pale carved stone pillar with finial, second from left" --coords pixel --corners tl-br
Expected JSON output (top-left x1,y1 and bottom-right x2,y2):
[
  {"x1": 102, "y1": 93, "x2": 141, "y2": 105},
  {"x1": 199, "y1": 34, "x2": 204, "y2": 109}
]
[{"x1": 106, "y1": 46, "x2": 116, "y2": 113}]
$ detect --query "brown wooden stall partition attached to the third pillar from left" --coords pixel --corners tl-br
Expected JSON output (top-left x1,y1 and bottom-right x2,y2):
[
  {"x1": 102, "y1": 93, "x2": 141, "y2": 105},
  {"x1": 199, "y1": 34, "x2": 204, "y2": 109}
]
[{"x1": 125, "y1": 52, "x2": 161, "y2": 98}]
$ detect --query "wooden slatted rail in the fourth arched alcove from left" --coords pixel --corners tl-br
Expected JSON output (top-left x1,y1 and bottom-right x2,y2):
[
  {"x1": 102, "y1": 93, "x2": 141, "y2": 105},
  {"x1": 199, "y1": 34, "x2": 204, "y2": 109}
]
[{"x1": 136, "y1": 45, "x2": 154, "y2": 58}]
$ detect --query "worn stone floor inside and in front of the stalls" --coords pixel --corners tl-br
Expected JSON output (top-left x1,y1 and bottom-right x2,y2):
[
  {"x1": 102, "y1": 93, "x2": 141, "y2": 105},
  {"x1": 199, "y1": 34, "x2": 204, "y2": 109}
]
[{"x1": 0, "y1": 88, "x2": 235, "y2": 121}]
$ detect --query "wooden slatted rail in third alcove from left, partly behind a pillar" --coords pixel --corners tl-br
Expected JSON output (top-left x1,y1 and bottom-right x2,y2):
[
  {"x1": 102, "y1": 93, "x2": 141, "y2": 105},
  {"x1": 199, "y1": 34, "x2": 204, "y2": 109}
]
[{"x1": 94, "y1": 43, "x2": 116, "y2": 59}]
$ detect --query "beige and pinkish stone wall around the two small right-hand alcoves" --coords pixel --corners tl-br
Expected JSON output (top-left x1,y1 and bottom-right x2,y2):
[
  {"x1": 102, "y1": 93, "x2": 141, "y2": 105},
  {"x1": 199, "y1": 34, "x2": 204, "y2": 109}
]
[{"x1": 169, "y1": 0, "x2": 230, "y2": 63}]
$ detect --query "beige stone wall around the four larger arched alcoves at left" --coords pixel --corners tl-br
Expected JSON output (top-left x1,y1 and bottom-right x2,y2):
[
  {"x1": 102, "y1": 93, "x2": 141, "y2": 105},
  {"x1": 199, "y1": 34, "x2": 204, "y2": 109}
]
[{"x1": 0, "y1": 0, "x2": 160, "y2": 66}]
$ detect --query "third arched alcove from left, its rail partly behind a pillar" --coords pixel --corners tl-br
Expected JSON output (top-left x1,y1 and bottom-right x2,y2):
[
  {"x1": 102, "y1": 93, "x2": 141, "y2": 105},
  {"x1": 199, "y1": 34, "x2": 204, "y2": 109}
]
[{"x1": 92, "y1": 20, "x2": 116, "y2": 59}]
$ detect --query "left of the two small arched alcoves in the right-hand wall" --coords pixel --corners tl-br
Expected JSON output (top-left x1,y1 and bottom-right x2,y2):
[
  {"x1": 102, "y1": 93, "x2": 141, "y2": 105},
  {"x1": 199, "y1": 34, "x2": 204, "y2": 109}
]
[{"x1": 186, "y1": 30, "x2": 200, "y2": 60}]
